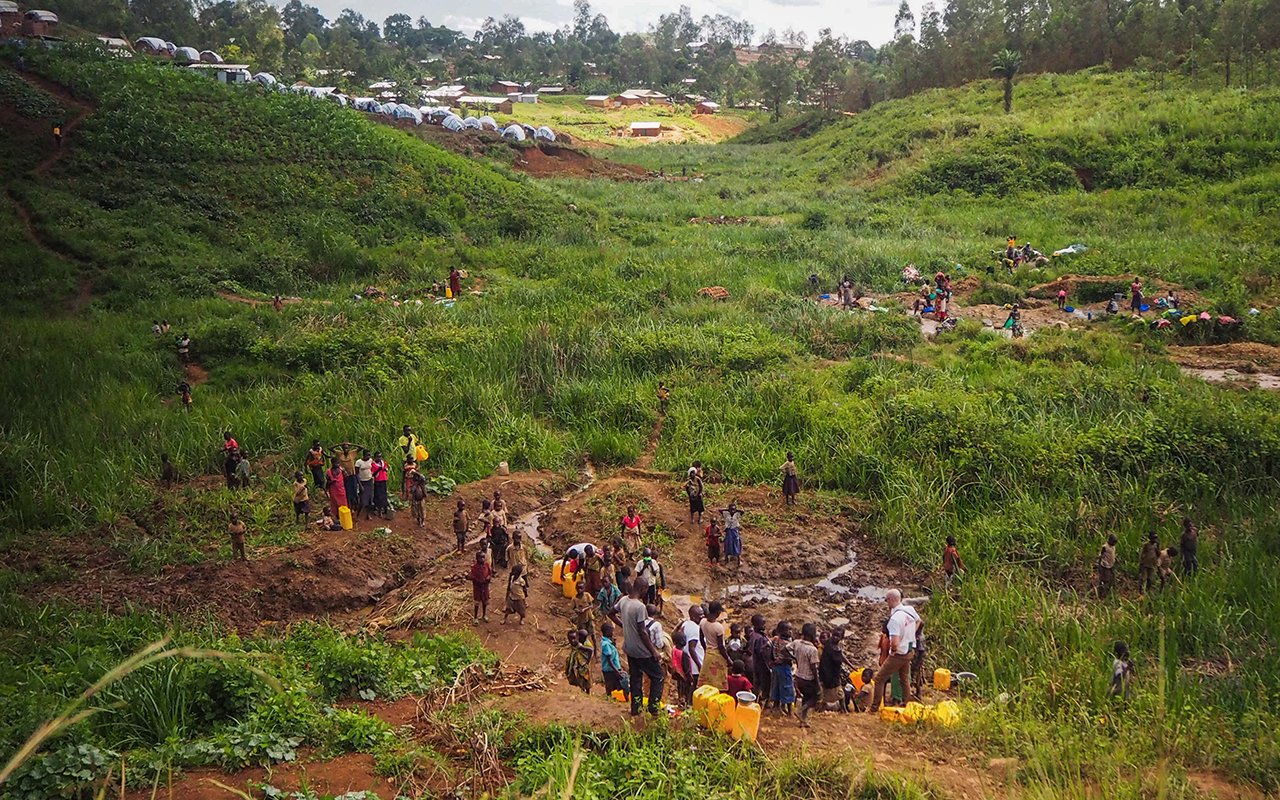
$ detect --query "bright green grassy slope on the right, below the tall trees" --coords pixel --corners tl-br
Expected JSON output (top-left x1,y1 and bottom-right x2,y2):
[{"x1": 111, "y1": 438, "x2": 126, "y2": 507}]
[{"x1": 591, "y1": 73, "x2": 1280, "y2": 307}]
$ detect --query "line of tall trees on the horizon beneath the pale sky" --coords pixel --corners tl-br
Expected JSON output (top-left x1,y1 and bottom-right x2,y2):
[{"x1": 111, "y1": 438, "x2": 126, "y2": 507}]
[{"x1": 46, "y1": 0, "x2": 1280, "y2": 116}]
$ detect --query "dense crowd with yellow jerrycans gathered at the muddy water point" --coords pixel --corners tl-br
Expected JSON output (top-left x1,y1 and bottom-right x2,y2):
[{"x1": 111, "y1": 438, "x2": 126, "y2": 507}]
[{"x1": 564, "y1": 567, "x2": 924, "y2": 727}]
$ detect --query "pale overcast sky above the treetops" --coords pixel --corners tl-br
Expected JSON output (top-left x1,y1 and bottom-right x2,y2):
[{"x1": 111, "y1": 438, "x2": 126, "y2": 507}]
[{"x1": 310, "y1": 0, "x2": 911, "y2": 45}]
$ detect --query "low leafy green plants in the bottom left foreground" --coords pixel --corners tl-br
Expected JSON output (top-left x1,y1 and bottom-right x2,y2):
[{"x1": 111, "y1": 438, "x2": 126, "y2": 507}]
[{"x1": 0, "y1": 602, "x2": 494, "y2": 800}]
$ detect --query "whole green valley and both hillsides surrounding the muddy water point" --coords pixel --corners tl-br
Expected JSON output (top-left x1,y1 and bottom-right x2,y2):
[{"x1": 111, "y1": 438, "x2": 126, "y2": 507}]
[{"x1": 0, "y1": 49, "x2": 1280, "y2": 800}]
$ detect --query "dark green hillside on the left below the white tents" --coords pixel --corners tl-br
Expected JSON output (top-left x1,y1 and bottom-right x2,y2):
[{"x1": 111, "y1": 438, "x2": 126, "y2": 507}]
[{"x1": 13, "y1": 48, "x2": 558, "y2": 305}]
